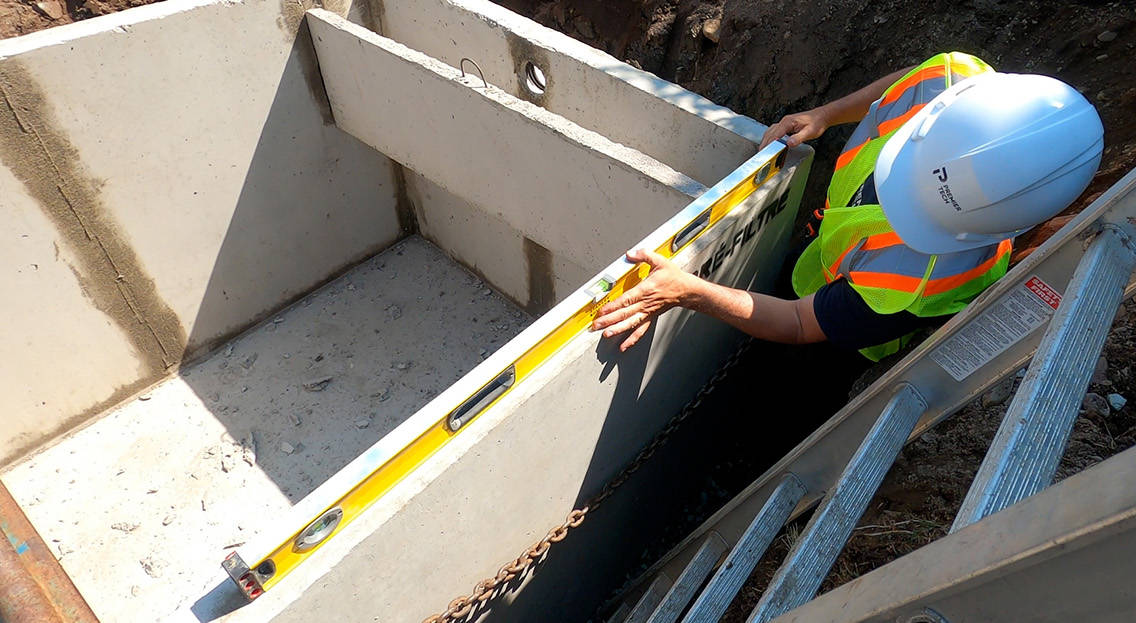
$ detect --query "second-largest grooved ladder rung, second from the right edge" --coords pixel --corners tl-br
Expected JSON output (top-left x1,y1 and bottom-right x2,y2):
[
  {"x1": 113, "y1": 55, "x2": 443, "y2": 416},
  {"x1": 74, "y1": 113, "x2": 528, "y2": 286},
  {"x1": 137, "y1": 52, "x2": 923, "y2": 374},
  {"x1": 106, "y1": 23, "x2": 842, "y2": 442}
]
[{"x1": 747, "y1": 383, "x2": 927, "y2": 623}]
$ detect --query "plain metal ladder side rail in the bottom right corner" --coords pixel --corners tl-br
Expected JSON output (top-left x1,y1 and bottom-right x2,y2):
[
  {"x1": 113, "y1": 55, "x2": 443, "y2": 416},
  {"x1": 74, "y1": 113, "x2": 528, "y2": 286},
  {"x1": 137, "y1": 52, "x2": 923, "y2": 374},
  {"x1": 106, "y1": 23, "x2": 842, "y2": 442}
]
[{"x1": 772, "y1": 448, "x2": 1136, "y2": 623}]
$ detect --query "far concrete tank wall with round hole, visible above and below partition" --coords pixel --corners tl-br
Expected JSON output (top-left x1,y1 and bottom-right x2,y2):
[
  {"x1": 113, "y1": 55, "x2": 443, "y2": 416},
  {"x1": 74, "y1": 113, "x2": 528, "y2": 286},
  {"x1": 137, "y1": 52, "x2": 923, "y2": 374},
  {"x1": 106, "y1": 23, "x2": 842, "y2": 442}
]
[{"x1": 366, "y1": 0, "x2": 765, "y2": 313}]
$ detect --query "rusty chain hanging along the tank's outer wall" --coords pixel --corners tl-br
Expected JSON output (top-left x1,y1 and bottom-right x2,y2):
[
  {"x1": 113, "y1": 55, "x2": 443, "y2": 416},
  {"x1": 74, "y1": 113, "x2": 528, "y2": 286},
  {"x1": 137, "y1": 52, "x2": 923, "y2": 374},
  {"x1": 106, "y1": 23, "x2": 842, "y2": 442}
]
[{"x1": 423, "y1": 338, "x2": 752, "y2": 623}]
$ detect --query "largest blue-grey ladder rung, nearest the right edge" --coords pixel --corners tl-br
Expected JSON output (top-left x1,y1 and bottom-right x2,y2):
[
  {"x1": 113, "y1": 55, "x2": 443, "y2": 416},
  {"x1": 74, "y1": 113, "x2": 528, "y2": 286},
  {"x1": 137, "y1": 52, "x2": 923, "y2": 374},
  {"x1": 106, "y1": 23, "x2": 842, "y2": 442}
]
[{"x1": 951, "y1": 225, "x2": 1136, "y2": 532}]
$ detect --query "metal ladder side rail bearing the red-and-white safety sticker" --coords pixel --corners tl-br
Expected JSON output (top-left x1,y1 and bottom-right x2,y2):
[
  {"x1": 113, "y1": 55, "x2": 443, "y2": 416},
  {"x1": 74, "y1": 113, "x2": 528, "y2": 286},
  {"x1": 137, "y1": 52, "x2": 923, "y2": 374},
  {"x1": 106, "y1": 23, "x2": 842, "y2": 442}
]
[{"x1": 612, "y1": 169, "x2": 1136, "y2": 605}]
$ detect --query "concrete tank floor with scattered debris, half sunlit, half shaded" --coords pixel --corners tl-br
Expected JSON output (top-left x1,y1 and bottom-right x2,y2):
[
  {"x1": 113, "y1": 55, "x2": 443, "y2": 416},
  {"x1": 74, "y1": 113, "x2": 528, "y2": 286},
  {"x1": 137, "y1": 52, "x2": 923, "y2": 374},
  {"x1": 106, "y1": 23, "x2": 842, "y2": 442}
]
[{"x1": 0, "y1": 236, "x2": 531, "y2": 623}]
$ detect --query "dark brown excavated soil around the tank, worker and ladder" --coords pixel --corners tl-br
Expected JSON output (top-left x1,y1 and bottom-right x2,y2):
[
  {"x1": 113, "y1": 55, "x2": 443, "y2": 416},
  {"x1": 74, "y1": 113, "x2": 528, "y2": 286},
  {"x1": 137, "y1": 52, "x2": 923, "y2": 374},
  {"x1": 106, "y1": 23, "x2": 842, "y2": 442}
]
[{"x1": 0, "y1": 0, "x2": 1136, "y2": 622}]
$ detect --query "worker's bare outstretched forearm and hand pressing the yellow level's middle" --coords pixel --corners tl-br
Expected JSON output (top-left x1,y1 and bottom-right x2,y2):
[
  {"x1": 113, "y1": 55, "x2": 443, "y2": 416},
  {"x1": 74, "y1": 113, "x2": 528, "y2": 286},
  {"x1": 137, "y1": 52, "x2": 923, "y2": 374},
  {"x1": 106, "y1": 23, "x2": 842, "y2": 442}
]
[{"x1": 592, "y1": 249, "x2": 825, "y2": 350}]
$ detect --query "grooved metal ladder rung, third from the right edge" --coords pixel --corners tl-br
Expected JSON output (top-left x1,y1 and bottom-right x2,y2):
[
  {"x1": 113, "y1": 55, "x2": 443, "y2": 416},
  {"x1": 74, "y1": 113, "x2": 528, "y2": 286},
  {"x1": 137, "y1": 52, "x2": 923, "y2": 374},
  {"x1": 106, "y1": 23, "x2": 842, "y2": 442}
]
[{"x1": 683, "y1": 473, "x2": 805, "y2": 623}]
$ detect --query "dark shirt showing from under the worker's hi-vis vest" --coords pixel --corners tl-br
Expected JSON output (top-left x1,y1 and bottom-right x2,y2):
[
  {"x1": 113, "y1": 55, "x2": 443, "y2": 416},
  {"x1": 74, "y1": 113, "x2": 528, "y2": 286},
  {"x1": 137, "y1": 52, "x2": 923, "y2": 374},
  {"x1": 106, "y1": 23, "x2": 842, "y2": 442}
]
[{"x1": 812, "y1": 175, "x2": 946, "y2": 349}]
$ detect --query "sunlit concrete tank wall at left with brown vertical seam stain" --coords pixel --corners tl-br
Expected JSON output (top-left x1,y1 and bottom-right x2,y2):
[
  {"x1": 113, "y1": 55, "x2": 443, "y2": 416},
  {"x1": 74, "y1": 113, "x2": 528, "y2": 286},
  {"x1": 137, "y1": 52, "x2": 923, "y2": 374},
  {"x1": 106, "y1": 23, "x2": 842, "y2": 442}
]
[{"x1": 0, "y1": 0, "x2": 400, "y2": 464}]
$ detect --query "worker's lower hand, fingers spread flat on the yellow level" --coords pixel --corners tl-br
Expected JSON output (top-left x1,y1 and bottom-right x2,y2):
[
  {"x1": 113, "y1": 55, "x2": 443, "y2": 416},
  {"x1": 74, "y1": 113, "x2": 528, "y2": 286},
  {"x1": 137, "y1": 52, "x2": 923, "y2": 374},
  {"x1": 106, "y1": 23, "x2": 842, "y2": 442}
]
[{"x1": 592, "y1": 249, "x2": 698, "y2": 351}]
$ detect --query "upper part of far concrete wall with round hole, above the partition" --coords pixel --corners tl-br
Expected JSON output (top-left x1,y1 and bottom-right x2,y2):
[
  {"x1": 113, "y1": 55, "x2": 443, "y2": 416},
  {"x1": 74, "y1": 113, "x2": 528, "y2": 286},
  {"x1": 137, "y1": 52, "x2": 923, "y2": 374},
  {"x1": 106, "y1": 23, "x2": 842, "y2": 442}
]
[{"x1": 369, "y1": 0, "x2": 766, "y2": 186}]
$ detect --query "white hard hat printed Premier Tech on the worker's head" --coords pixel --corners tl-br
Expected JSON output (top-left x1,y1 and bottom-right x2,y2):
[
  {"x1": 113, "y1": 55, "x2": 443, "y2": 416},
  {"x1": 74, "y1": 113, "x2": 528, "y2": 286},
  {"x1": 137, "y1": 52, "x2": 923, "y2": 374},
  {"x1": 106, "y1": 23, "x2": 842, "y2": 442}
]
[{"x1": 875, "y1": 72, "x2": 1104, "y2": 254}]
